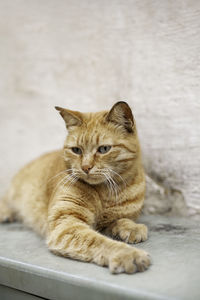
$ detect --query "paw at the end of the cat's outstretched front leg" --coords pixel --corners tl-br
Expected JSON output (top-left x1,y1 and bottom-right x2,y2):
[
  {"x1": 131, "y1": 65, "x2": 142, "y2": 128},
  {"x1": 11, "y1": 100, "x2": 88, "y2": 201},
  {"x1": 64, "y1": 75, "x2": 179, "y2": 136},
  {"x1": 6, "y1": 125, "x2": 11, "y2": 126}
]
[{"x1": 109, "y1": 247, "x2": 151, "y2": 274}]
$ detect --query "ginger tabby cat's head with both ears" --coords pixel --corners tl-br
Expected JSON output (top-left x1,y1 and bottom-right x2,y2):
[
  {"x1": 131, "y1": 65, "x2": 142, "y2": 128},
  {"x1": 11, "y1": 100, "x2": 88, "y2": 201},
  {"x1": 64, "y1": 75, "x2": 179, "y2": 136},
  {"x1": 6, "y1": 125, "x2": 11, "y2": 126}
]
[{"x1": 56, "y1": 102, "x2": 139, "y2": 184}]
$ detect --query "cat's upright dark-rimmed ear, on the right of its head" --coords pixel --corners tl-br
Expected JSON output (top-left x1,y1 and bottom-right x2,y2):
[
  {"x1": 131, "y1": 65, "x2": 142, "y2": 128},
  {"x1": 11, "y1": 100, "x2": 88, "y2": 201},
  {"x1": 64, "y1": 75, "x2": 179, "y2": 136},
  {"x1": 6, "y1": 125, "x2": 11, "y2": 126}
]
[{"x1": 106, "y1": 101, "x2": 134, "y2": 132}]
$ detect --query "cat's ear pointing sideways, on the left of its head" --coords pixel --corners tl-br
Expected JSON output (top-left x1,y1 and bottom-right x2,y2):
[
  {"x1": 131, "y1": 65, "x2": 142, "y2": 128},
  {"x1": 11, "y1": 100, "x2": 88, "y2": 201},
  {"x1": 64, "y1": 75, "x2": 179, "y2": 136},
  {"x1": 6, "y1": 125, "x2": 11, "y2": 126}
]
[{"x1": 55, "y1": 106, "x2": 83, "y2": 128}]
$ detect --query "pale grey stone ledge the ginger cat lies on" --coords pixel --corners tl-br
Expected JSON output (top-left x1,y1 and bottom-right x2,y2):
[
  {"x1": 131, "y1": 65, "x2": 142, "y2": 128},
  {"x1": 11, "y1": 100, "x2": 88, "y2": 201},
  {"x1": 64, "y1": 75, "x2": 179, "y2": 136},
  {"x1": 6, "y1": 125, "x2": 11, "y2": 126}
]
[{"x1": 0, "y1": 216, "x2": 200, "y2": 300}]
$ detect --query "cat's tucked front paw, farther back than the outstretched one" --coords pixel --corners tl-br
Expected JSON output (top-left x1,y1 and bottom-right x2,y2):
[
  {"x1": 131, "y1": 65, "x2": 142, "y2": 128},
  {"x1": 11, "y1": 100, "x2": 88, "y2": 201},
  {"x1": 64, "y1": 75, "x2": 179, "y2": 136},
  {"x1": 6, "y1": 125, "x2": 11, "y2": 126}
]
[{"x1": 105, "y1": 218, "x2": 148, "y2": 244}]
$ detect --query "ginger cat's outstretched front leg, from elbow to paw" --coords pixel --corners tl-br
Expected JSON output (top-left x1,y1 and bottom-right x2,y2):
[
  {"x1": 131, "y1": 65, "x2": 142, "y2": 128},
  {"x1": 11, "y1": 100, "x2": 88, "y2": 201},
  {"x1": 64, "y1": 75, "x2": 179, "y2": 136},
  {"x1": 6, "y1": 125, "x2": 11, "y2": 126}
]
[{"x1": 47, "y1": 205, "x2": 150, "y2": 273}]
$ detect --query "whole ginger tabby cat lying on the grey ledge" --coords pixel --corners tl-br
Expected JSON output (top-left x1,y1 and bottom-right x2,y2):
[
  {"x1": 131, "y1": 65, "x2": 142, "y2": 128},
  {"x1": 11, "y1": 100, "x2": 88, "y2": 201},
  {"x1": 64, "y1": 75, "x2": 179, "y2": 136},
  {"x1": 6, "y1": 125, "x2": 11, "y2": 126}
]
[{"x1": 0, "y1": 101, "x2": 150, "y2": 273}]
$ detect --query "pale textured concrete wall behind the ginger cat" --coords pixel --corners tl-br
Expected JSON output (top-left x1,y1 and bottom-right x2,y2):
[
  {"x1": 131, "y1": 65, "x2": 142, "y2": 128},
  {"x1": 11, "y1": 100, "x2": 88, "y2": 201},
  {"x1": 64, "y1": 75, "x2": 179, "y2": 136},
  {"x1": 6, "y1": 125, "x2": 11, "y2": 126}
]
[{"x1": 0, "y1": 0, "x2": 200, "y2": 215}]
